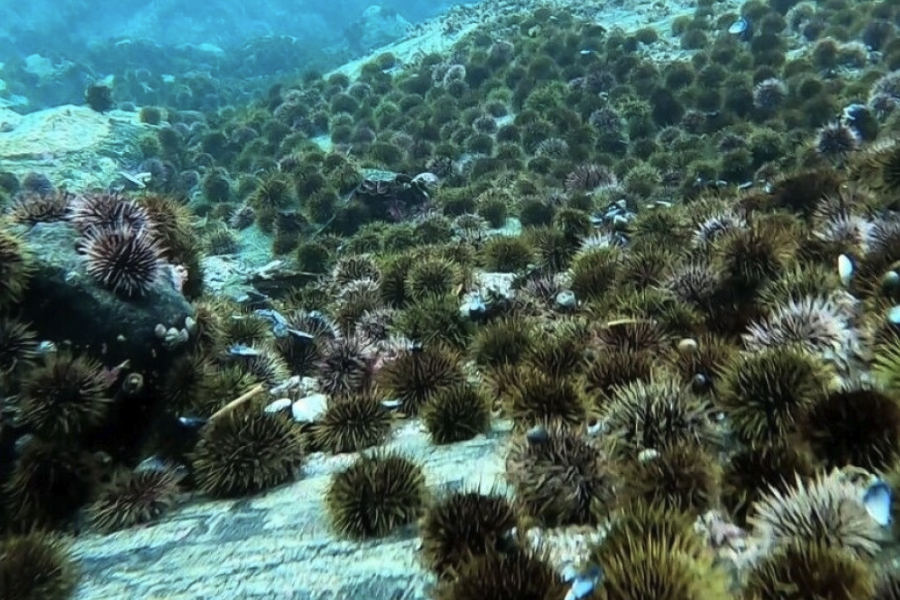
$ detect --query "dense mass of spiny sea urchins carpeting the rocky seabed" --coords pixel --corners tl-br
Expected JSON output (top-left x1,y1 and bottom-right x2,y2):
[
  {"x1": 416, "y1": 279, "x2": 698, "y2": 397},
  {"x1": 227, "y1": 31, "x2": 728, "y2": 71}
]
[{"x1": 0, "y1": 2, "x2": 900, "y2": 600}]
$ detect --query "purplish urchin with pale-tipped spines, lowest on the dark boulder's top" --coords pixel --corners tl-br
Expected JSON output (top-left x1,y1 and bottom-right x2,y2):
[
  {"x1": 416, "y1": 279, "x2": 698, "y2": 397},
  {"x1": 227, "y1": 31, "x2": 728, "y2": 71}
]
[{"x1": 81, "y1": 227, "x2": 164, "y2": 297}]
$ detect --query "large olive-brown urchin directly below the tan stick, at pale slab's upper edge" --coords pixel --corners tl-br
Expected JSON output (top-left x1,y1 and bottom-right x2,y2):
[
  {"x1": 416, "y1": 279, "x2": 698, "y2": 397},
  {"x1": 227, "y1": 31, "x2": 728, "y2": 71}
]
[{"x1": 190, "y1": 402, "x2": 304, "y2": 497}]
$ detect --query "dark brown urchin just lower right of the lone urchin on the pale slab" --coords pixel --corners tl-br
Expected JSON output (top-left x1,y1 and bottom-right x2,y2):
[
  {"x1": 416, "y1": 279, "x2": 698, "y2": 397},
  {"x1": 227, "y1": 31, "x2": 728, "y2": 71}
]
[{"x1": 419, "y1": 491, "x2": 519, "y2": 577}]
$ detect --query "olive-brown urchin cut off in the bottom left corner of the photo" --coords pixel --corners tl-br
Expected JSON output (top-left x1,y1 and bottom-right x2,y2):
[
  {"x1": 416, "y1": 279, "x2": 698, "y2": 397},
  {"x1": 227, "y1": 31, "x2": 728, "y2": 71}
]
[{"x1": 0, "y1": 532, "x2": 79, "y2": 600}]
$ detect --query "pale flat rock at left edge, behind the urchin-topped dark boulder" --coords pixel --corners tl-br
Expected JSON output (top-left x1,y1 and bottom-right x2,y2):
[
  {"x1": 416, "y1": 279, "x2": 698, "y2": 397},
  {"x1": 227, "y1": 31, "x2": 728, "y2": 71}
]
[{"x1": 0, "y1": 104, "x2": 152, "y2": 190}]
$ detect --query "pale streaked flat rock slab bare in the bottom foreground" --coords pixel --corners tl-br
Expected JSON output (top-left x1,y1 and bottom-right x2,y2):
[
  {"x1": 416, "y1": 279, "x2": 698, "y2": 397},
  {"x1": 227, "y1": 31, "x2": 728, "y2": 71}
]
[{"x1": 75, "y1": 421, "x2": 509, "y2": 600}]
